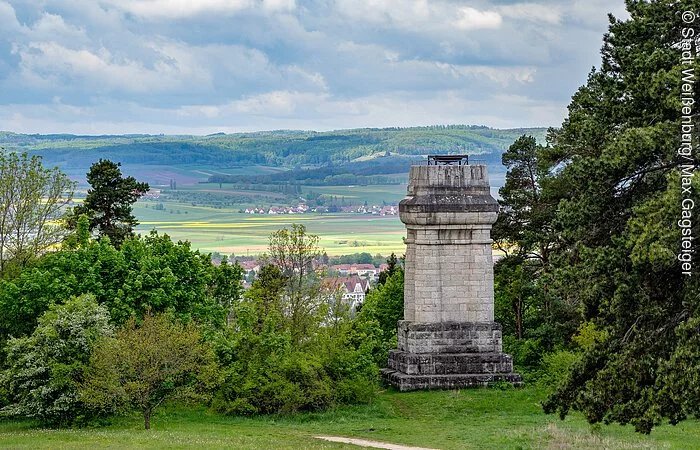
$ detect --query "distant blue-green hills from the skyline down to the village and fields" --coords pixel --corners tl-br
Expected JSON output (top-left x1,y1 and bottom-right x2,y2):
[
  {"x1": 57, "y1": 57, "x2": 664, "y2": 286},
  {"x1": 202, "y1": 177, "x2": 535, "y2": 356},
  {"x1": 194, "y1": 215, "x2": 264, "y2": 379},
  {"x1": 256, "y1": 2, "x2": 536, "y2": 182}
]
[{"x1": 0, "y1": 125, "x2": 546, "y2": 184}]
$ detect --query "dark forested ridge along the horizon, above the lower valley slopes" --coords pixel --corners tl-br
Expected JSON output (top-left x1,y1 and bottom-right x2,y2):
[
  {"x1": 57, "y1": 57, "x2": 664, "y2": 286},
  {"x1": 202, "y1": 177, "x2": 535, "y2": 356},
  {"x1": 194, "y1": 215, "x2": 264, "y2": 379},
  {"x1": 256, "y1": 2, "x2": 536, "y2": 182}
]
[{"x1": 0, "y1": 125, "x2": 546, "y2": 167}]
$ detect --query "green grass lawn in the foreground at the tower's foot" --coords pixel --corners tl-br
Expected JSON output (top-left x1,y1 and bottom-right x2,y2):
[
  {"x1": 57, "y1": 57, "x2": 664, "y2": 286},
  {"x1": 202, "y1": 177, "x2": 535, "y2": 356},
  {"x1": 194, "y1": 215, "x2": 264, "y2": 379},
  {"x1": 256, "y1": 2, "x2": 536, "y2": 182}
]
[{"x1": 0, "y1": 388, "x2": 700, "y2": 449}]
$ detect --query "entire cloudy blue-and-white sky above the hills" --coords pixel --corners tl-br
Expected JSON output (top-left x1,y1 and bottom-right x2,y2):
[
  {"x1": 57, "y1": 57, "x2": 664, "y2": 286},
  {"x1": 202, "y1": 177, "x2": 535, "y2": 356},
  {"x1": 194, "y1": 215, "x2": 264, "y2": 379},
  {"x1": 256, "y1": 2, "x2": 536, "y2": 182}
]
[{"x1": 0, "y1": 0, "x2": 625, "y2": 134}]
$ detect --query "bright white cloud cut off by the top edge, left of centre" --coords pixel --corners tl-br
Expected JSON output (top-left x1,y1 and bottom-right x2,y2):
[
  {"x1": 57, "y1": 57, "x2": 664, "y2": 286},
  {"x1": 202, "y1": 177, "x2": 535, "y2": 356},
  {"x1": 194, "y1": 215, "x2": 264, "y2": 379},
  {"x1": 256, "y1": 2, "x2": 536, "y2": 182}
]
[{"x1": 99, "y1": 0, "x2": 296, "y2": 19}]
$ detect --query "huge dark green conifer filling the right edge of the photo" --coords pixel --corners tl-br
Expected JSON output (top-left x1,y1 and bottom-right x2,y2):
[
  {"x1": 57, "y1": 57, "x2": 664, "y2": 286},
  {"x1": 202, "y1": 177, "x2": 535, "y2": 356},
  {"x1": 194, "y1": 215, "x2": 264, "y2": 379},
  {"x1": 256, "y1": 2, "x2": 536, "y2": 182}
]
[{"x1": 543, "y1": 0, "x2": 700, "y2": 433}]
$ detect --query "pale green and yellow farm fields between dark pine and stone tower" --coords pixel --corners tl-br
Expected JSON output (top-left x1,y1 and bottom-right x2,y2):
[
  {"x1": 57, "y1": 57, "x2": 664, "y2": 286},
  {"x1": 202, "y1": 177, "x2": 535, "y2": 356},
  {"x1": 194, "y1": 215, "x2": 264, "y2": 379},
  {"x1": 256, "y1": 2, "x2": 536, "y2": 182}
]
[{"x1": 134, "y1": 202, "x2": 405, "y2": 256}]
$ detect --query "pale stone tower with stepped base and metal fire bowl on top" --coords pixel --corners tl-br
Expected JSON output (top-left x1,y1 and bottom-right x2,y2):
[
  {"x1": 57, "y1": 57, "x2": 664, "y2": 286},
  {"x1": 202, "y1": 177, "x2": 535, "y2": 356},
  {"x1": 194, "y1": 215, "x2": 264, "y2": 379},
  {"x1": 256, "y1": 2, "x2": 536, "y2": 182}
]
[{"x1": 382, "y1": 155, "x2": 521, "y2": 391}]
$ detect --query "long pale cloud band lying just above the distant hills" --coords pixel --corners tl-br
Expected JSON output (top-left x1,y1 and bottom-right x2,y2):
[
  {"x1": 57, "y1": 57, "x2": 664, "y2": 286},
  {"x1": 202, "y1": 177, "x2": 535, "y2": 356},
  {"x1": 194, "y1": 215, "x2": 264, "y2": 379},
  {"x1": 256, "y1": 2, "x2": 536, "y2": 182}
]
[{"x1": 0, "y1": 84, "x2": 565, "y2": 134}]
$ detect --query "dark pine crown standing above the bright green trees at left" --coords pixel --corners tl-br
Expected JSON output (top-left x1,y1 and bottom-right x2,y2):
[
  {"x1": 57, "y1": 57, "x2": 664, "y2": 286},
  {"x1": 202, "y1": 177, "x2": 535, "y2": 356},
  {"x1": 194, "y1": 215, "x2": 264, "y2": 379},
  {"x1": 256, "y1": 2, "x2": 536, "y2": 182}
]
[{"x1": 69, "y1": 159, "x2": 149, "y2": 247}]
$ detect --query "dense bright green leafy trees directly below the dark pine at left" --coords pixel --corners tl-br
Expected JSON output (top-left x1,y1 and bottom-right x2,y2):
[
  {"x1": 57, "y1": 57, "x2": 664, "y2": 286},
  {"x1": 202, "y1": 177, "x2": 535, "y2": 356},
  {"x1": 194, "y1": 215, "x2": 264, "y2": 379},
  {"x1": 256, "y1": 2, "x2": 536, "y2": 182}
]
[{"x1": 0, "y1": 232, "x2": 241, "y2": 336}]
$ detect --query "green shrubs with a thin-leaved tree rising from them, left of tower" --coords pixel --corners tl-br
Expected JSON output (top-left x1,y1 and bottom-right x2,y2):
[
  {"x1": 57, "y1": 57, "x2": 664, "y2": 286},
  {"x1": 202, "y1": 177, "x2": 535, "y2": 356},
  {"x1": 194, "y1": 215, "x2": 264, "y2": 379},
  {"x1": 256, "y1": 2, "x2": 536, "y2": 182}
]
[{"x1": 213, "y1": 225, "x2": 378, "y2": 414}]
